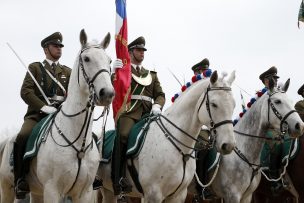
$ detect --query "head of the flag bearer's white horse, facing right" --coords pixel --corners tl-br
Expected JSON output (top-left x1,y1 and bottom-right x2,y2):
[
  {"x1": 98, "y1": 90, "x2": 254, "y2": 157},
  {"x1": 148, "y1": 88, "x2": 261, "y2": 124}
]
[{"x1": 198, "y1": 71, "x2": 235, "y2": 154}]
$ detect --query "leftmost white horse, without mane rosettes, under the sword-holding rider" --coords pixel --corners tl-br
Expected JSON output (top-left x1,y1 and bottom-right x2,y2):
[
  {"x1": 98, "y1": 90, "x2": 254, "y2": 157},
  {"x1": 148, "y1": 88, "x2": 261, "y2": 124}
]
[{"x1": 0, "y1": 30, "x2": 114, "y2": 203}]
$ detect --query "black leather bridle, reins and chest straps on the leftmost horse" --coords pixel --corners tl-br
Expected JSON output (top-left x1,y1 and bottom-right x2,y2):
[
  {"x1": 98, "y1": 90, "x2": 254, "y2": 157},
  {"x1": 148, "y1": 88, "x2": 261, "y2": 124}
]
[{"x1": 49, "y1": 46, "x2": 110, "y2": 191}]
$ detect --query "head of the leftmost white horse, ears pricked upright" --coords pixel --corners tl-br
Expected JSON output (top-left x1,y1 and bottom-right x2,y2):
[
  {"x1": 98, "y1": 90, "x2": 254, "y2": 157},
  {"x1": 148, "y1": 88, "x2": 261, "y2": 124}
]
[{"x1": 78, "y1": 30, "x2": 114, "y2": 106}]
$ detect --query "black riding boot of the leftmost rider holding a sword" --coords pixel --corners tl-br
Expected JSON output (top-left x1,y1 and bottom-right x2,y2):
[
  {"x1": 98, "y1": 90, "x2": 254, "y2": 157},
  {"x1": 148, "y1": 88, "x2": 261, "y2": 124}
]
[{"x1": 14, "y1": 142, "x2": 30, "y2": 199}]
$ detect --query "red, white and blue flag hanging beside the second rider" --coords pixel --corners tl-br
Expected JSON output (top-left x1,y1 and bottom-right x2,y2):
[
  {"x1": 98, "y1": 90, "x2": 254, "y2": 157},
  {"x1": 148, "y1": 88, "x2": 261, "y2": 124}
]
[{"x1": 112, "y1": 0, "x2": 131, "y2": 123}]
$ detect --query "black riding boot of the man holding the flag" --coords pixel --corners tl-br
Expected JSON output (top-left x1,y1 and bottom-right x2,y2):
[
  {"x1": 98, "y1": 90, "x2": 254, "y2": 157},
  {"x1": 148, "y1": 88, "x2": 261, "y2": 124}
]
[{"x1": 119, "y1": 143, "x2": 132, "y2": 193}]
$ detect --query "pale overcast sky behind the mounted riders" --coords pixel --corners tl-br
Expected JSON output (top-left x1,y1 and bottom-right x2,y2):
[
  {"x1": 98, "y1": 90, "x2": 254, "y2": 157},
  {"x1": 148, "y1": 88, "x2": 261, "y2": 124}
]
[{"x1": 0, "y1": 0, "x2": 304, "y2": 135}]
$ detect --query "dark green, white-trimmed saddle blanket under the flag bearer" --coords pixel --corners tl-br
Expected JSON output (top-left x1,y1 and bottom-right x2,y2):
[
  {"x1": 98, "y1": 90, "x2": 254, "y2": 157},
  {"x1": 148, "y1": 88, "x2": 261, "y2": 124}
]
[{"x1": 97, "y1": 117, "x2": 151, "y2": 163}]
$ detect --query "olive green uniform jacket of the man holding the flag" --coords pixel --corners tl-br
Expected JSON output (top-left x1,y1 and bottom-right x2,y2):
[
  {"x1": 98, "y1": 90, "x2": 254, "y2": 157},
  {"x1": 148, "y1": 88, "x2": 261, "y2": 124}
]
[{"x1": 123, "y1": 66, "x2": 166, "y2": 120}]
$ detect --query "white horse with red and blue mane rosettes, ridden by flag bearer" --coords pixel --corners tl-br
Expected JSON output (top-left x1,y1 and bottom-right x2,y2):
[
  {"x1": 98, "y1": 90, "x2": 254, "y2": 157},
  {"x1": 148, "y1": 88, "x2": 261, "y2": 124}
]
[{"x1": 98, "y1": 71, "x2": 235, "y2": 203}]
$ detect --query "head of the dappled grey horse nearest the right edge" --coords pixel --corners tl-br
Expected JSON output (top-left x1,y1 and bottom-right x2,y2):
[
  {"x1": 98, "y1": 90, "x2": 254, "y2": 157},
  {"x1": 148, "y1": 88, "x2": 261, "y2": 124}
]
[{"x1": 262, "y1": 79, "x2": 304, "y2": 138}]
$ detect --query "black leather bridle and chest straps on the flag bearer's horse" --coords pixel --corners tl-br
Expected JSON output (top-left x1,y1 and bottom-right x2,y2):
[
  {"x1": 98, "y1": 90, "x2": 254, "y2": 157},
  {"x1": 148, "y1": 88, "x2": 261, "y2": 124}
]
[{"x1": 155, "y1": 84, "x2": 233, "y2": 196}]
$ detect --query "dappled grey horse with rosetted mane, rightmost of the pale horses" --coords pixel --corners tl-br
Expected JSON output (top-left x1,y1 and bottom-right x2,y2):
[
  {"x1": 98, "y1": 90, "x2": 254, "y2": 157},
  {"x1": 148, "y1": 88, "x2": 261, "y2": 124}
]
[{"x1": 212, "y1": 80, "x2": 304, "y2": 203}]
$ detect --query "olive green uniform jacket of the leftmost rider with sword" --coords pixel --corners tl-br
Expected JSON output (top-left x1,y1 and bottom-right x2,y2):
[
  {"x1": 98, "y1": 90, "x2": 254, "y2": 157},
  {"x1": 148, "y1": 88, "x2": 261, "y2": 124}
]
[{"x1": 20, "y1": 60, "x2": 71, "y2": 120}]
